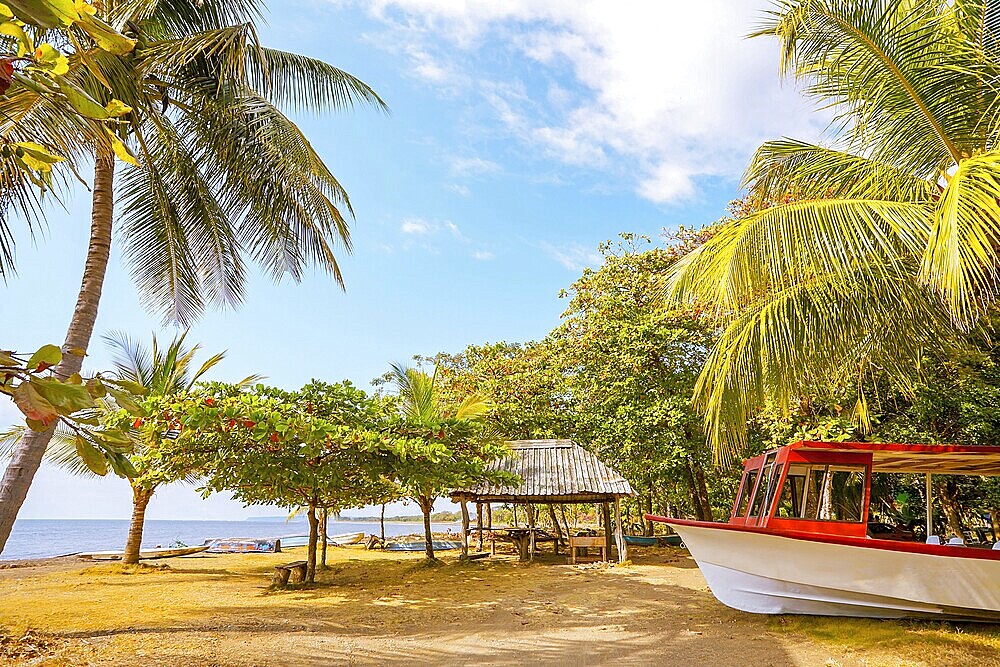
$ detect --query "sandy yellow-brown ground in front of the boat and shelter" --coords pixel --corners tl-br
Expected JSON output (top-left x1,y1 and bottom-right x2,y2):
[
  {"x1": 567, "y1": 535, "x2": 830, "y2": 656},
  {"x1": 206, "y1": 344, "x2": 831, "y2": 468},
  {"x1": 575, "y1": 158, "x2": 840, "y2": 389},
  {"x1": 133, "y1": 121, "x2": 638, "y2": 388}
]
[{"x1": 0, "y1": 547, "x2": 1000, "y2": 667}]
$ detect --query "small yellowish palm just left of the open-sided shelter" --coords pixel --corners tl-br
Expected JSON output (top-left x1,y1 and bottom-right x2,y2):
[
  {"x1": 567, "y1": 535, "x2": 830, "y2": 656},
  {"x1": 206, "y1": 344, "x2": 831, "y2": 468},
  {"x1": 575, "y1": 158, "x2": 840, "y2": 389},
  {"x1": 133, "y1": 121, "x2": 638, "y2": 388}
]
[{"x1": 389, "y1": 364, "x2": 489, "y2": 560}]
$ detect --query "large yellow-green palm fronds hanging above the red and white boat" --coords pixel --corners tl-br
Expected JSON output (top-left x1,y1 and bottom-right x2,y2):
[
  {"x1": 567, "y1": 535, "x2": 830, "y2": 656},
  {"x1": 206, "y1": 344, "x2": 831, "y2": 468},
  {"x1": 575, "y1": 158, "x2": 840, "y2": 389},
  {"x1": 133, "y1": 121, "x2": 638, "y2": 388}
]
[{"x1": 672, "y1": 0, "x2": 1000, "y2": 457}]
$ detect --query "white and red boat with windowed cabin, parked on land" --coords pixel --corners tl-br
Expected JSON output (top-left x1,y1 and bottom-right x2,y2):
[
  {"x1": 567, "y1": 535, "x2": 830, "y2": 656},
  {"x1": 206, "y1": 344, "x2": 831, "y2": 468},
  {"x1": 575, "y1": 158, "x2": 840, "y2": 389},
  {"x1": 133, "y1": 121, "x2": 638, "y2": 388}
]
[{"x1": 647, "y1": 442, "x2": 1000, "y2": 622}]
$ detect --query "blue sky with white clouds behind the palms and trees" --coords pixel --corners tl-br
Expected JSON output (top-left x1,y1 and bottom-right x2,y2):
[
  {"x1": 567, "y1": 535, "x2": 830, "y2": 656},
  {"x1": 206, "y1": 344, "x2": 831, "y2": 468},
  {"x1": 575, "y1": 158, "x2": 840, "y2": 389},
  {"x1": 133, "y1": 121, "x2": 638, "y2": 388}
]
[{"x1": 0, "y1": 0, "x2": 825, "y2": 519}]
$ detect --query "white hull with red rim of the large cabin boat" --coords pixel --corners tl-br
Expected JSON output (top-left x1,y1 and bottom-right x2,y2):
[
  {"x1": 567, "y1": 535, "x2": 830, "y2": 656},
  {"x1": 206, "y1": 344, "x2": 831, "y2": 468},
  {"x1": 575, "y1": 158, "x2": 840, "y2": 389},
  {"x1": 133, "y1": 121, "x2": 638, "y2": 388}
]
[{"x1": 667, "y1": 521, "x2": 1000, "y2": 623}]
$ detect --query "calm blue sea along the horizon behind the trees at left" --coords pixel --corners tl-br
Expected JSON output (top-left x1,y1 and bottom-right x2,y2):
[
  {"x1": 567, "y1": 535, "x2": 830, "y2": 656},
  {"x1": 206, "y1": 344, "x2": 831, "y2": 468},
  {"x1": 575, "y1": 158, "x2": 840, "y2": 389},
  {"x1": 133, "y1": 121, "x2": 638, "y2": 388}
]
[{"x1": 0, "y1": 519, "x2": 458, "y2": 560}]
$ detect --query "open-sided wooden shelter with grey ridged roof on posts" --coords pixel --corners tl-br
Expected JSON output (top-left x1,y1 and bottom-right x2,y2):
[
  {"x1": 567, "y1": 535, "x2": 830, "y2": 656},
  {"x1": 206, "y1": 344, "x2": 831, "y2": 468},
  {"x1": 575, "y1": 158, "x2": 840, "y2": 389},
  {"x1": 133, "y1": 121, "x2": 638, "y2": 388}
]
[{"x1": 451, "y1": 440, "x2": 634, "y2": 562}]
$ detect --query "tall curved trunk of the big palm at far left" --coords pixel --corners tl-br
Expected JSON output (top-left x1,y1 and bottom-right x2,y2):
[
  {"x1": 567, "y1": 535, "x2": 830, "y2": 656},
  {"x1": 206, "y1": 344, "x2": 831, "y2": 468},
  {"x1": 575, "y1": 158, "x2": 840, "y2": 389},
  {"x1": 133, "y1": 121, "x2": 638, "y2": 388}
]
[{"x1": 0, "y1": 152, "x2": 115, "y2": 553}]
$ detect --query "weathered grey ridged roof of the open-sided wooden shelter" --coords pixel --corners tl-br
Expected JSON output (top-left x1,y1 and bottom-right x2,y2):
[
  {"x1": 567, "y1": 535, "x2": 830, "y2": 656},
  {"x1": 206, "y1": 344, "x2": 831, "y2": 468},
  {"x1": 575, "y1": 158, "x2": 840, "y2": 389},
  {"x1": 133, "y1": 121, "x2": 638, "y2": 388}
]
[{"x1": 451, "y1": 440, "x2": 633, "y2": 503}]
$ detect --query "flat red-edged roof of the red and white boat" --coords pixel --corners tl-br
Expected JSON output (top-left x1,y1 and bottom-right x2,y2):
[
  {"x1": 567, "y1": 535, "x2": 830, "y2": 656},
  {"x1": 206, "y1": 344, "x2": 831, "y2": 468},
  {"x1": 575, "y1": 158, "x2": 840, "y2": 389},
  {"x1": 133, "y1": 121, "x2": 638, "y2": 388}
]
[{"x1": 788, "y1": 440, "x2": 1000, "y2": 476}]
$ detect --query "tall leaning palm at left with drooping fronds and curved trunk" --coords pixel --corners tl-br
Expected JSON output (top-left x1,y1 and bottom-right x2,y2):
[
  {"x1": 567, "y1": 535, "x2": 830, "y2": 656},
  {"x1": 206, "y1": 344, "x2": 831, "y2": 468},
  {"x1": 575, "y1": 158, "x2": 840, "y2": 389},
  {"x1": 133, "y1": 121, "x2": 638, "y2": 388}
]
[{"x1": 0, "y1": 0, "x2": 385, "y2": 550}]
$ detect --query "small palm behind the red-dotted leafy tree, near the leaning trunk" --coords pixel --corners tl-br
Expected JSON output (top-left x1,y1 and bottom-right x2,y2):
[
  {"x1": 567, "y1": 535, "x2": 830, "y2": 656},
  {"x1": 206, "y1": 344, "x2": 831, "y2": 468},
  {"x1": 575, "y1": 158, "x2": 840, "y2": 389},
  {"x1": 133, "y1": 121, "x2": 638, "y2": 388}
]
[{"x1": 0, "y1": 332, "x2": 261, "y2": 564}]
